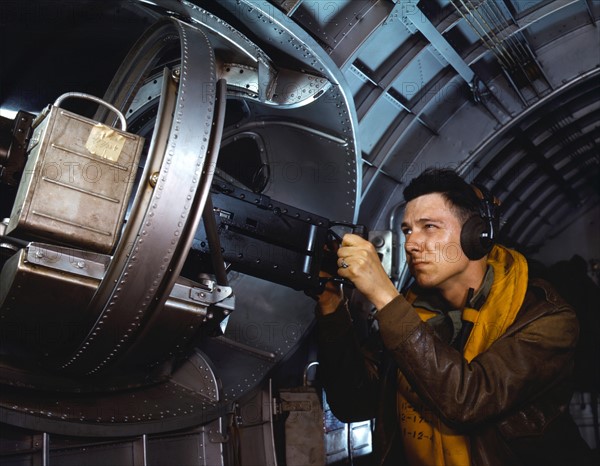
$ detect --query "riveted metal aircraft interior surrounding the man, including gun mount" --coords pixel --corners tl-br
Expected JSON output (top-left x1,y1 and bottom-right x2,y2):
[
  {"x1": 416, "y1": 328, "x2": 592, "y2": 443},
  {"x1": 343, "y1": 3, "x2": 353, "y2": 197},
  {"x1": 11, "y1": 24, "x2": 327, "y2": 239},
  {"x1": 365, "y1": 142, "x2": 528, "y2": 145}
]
[{"x1": 0, "y1": 0, "x2": 600, "y2": 466}]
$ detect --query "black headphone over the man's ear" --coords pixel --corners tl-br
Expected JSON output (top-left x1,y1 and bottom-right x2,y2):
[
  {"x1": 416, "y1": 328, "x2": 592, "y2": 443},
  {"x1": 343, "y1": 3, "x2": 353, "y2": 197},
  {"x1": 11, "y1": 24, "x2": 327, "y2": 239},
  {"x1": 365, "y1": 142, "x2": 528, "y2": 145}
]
[{"x1": 460, "y1": 184, "x2": 500, "y2": 261}]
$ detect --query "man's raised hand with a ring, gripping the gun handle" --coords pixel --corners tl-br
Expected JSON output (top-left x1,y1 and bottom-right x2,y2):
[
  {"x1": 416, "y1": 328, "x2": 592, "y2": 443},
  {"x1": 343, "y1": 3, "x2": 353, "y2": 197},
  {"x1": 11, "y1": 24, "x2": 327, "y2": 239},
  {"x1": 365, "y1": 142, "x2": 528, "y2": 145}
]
[{"x1": 337, "y1": 234, "x2": 399, "y2": 310}]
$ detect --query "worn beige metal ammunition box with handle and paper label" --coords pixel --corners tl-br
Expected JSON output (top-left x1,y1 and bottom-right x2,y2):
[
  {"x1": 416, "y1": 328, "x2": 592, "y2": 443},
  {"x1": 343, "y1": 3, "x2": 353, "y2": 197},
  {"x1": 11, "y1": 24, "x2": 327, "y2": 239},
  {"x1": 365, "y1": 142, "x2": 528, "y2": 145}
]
[{"x1": 6, "y1": 94, "x2": 144, "y2": 253}]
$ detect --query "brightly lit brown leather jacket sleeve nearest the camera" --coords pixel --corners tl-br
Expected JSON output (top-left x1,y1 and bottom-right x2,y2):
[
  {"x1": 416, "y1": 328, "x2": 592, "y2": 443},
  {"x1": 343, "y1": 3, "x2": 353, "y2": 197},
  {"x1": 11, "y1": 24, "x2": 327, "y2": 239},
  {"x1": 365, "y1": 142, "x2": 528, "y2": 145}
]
[{"x1": 377, "y1": 290, "x2": 578, "y2": 429}]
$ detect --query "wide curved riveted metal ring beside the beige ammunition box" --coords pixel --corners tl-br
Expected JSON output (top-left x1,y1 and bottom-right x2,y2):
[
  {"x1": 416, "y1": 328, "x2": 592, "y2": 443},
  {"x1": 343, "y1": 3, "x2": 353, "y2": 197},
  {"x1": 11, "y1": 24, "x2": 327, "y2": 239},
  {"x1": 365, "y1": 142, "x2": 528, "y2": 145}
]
[{"x1": 58, "y1": 18, "x2": 216, "y2": 375}]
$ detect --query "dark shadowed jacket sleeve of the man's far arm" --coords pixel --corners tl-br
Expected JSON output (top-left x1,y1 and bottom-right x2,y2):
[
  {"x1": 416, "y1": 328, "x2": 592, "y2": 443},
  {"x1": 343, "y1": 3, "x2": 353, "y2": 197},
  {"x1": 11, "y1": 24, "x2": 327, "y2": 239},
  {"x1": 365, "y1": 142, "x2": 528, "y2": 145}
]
[{"x1": 317, "y1": 302, "x2": 379, "y2": 422}]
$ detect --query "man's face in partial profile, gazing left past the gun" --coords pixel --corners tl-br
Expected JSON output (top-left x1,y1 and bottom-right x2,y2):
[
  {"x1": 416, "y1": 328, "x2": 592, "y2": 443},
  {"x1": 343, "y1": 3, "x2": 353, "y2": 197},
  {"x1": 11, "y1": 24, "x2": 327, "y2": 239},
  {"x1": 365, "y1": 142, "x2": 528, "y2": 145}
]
[{"x1": 402, "y1": 193, "x2": 469, "y2": 288}]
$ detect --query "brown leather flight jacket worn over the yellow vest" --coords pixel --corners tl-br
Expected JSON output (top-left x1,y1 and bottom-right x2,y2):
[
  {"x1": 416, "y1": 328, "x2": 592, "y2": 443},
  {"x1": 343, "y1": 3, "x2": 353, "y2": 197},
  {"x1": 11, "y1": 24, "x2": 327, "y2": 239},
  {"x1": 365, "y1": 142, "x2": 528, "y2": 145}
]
[{"x1": 317, "y1": 280, "x2": 597, "y2": 466}]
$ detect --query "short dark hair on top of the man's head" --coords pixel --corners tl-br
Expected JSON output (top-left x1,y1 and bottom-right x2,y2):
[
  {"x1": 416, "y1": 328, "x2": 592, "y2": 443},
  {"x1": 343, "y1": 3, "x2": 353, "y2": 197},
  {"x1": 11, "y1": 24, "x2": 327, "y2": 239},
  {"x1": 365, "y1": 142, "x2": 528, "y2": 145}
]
[{"x1": 403, "y1": 168, "x2": 480, "y2": 222}]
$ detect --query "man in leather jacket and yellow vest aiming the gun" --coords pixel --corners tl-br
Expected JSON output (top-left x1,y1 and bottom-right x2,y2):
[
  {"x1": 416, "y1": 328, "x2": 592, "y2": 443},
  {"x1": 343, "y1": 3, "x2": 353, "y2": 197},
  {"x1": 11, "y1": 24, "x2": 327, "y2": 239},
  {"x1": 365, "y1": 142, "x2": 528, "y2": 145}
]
[{"x1": 318, "y1": 170, "x2": 589, "y2": 466}]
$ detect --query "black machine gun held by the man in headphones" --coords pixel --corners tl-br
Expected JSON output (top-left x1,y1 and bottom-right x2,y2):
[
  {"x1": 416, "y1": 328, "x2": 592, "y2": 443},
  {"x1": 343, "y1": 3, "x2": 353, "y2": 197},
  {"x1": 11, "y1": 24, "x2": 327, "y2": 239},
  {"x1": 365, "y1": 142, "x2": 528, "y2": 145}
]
[{"x1": 184, "y1": 181, "x2": 368, "y2": 292}]
